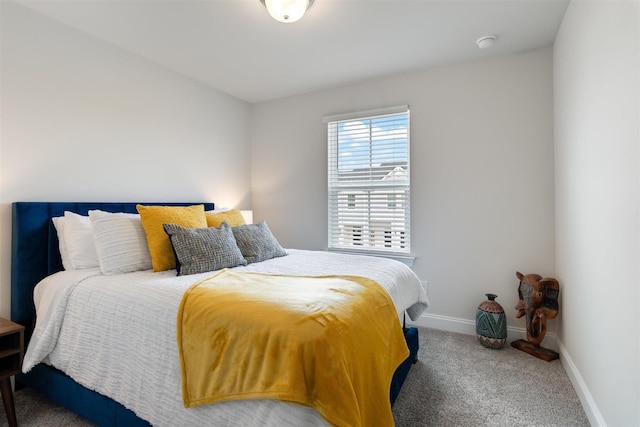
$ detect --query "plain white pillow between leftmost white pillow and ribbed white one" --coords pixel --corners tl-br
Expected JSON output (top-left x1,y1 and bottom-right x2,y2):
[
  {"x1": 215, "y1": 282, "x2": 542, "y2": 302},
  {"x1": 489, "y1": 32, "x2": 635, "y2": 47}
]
[{"x1": 63, "y1": 211, "x2": 100, "y2": 270}]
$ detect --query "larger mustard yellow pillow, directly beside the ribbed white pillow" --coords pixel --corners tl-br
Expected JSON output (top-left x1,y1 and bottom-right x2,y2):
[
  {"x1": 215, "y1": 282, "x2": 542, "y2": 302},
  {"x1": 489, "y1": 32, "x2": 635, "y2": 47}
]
[{"x1": 136, "y1": 205, "x2": 207, "y2": 271}]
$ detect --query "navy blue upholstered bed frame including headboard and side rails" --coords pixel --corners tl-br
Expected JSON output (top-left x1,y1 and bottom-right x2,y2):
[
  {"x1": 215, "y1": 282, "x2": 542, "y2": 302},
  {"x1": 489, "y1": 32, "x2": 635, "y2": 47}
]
[{"x1": 11, "y1": 202, "x2": 418, "y2": 427}]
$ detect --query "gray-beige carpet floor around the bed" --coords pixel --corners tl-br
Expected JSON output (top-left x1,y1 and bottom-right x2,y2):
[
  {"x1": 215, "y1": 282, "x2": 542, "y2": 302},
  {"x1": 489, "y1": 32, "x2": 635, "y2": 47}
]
[{"x1": 0, "y1": 328, "x2": 589, "y2": 427}]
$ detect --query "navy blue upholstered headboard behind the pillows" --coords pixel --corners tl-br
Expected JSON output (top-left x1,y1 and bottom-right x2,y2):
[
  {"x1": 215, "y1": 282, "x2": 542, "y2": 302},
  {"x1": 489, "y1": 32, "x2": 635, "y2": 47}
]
[{"x1": 11, "y1": 202, "x2": 213, "y2": 330}]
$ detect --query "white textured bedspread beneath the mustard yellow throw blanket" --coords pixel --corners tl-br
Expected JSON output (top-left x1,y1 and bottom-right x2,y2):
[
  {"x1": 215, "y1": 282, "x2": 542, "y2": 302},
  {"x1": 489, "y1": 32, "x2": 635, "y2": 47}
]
[{"x1": 23, "y1": 249, "x2": 428, "y2": 426}]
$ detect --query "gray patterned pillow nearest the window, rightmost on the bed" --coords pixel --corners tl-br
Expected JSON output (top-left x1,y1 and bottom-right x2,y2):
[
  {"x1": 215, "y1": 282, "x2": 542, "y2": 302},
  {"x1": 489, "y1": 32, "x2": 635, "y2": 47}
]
[{"x1": 231, "y1": 221, "x2": 287, "y2": 264}]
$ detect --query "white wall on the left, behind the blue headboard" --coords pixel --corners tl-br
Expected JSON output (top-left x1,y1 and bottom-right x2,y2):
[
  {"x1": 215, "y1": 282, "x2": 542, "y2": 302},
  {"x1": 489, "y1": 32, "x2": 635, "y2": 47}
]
[{"x1": 0, "y1": 1, "x2": 251, "y2": 317}]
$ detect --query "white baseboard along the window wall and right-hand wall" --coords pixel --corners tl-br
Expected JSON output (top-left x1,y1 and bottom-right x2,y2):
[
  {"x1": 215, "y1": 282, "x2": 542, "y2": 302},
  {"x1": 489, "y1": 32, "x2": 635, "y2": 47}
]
[{"x1": 407, "y1": 314, "x2": 607, "y2": 427}]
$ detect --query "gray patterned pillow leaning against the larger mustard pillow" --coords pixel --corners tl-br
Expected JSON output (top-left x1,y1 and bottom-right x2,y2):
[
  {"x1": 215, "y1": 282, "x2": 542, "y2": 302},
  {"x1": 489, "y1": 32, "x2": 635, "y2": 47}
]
[{"x1": 163, "y1": 221, "x2": 247, "y2": 276}]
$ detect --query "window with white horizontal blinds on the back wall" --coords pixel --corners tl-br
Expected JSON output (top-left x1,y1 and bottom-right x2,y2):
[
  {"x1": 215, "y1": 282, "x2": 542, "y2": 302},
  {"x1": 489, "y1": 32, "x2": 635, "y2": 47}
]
[{"x1": 324, "y1": 106, "x2": 410, "y2": 254}]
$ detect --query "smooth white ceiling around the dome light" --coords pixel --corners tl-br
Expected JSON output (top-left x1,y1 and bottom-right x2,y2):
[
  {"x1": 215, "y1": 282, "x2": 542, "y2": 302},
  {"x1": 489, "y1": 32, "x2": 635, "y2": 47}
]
[{"x1": 18, "y1": 0, "x2": 569, "y2": 102}]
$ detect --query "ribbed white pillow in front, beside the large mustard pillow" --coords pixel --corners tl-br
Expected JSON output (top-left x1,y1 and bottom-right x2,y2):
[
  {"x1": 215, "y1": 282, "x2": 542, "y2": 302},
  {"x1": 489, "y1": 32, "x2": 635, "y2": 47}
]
[{"x1": 89, "y1": 210, "x2": 152, "y2": 275}]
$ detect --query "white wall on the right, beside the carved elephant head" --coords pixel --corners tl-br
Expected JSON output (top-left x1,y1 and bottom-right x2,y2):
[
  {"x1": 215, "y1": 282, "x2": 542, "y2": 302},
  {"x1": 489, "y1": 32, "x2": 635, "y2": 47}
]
[{"x1": 554, "y1": 1, "x2": 640, "y2": 426}]
